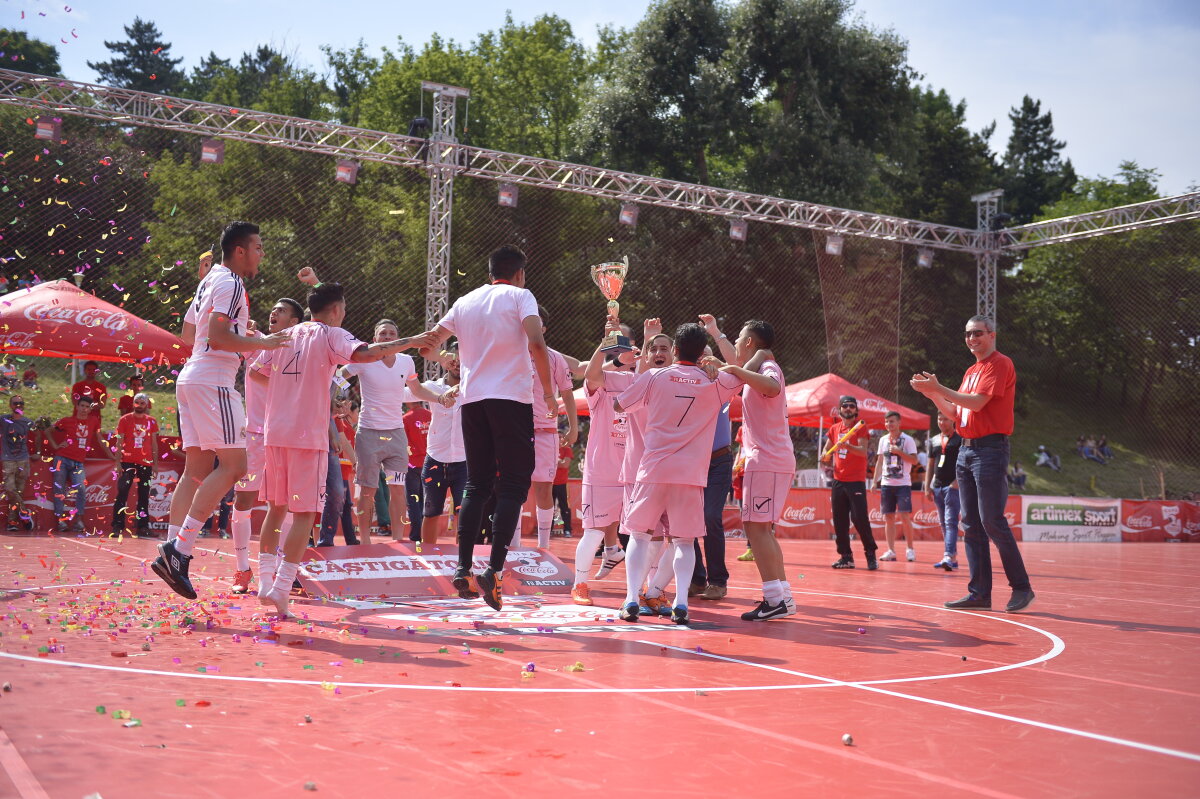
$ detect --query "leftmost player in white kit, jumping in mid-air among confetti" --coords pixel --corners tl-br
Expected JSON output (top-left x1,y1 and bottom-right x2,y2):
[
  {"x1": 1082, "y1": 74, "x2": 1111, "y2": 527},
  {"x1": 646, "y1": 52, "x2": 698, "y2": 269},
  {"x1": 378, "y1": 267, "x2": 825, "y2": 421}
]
[{"x1": 151, "y1": 222, "x2": 290, "y2": 599}]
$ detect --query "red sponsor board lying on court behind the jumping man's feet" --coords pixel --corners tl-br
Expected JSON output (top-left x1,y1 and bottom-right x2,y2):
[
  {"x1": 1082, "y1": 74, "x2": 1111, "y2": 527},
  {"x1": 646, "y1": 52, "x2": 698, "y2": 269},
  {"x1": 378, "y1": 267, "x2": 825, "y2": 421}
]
[{"x1": 299, "y1": 541, "x2": 574, "y2": 599}]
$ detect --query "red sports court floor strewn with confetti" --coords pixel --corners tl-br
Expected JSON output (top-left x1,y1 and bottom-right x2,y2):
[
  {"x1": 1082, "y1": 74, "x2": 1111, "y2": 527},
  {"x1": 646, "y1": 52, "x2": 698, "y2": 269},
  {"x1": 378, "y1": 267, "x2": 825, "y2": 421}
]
[{"x1": 0, "y1": 527, "x2": 1200, "y2": 799}]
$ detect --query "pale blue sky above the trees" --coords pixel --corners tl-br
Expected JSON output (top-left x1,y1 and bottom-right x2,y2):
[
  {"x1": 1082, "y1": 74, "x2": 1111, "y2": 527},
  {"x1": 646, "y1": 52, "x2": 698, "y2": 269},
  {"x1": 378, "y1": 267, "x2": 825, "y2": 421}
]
[{"x1": 9, "y1": 0, "x2": 1200, "y2": 199}]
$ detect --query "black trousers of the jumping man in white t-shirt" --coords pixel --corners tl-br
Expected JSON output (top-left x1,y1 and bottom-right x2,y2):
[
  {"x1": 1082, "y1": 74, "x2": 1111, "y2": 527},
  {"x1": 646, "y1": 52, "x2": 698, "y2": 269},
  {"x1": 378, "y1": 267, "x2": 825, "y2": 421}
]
[{"x1": 458, "y1": 400, "x2": 534, "y2": 572}]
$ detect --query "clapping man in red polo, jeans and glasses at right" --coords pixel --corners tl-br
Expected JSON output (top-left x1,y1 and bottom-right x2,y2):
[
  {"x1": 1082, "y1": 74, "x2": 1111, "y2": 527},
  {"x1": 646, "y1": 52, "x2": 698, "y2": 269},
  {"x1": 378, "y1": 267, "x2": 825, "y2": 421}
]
[{"x1": 910, "y1": 316, "x2": 1033, "y2": 613}]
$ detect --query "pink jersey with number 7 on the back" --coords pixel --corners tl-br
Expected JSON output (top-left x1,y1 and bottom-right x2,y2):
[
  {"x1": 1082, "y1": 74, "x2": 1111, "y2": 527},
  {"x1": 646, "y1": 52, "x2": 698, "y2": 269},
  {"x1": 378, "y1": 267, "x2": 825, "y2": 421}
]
[{"x1": 618, "y1": 364, "x2": 742, "y2": 486}]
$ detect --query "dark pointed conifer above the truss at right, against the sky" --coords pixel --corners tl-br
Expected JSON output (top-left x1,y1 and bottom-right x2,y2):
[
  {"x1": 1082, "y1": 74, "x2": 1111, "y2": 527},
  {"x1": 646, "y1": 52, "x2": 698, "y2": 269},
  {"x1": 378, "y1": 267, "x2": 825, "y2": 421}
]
[{"x1": 1002, "y1": 95, "x2": 1075, "y2": 223}]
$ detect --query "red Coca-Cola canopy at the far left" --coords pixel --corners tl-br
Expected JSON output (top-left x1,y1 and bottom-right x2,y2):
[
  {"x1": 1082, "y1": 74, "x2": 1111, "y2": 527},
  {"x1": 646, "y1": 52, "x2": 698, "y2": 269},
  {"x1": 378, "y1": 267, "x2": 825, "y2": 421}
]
[{"x1": 0, "y1": 281, "x2": 192, "y2": 366}]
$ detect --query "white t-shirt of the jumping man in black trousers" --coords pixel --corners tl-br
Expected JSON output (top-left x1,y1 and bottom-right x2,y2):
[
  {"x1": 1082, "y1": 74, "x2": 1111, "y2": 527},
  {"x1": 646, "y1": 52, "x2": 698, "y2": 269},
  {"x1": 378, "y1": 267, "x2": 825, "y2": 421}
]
[{"x1": 438, "y1": 283, "x2": 538, "y2": 405}]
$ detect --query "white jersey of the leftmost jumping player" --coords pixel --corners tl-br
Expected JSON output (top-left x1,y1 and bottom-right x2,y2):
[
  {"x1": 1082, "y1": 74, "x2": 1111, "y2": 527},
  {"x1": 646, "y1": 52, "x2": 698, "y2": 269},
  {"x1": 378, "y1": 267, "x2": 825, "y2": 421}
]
[{"x1": 175, "y1": 264, "x2": 250, "y2": 389}]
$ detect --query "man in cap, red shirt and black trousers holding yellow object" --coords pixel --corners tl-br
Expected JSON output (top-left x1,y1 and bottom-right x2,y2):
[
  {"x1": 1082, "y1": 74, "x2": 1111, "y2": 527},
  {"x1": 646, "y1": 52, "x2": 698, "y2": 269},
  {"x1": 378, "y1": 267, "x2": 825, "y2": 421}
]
[{"x1": 822, "y1": 395, "x2": 878, "y2": 571}]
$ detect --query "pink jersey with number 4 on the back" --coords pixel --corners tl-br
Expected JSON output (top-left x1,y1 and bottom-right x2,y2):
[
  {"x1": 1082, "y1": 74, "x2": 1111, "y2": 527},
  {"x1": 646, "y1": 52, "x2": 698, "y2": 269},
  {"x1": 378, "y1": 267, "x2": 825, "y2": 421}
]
[{"x1": 252, "y1": 322, "x2": 366, "y2": 450}]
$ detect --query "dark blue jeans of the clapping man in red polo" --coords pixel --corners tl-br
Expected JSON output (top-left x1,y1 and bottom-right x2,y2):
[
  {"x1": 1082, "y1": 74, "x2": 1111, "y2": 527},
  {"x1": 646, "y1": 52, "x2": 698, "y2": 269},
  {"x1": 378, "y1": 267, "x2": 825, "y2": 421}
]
[{"x1": 955, "y1": 439, "x2": 1030, "y2": 599}]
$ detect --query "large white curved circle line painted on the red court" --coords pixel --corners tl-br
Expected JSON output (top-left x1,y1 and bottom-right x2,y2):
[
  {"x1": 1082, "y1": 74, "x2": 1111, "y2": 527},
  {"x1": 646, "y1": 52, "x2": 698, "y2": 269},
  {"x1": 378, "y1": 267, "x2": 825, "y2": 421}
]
[{"x1": 0, "y1": 591, "x2": 1067, "y2": 693}]
